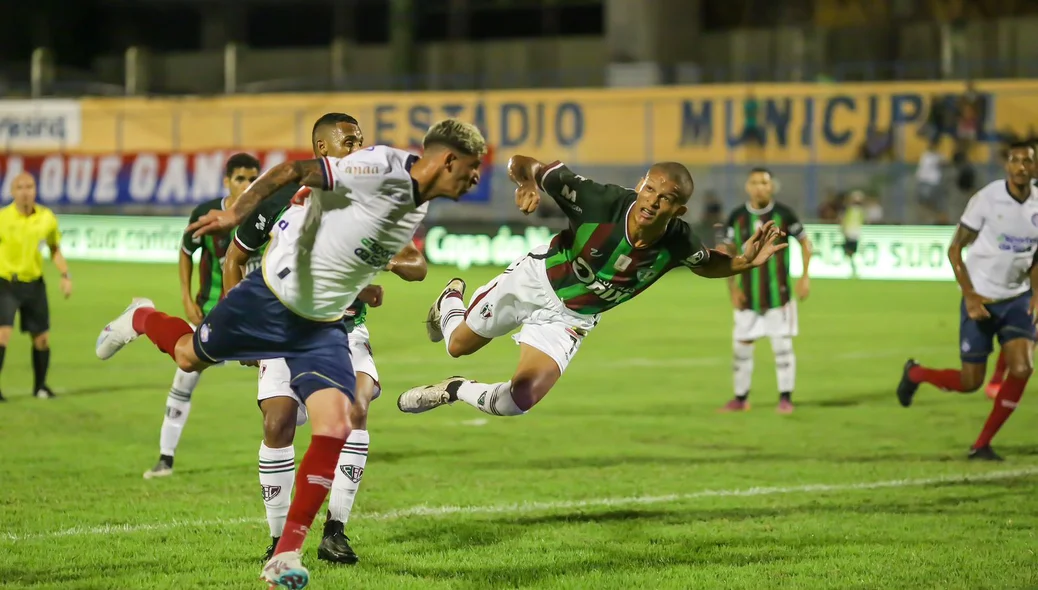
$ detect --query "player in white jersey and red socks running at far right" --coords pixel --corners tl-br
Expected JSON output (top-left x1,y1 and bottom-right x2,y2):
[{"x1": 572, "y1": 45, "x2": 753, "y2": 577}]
[{"x1": 897, "y1": 143, "x2": 1038, "y2": 461}]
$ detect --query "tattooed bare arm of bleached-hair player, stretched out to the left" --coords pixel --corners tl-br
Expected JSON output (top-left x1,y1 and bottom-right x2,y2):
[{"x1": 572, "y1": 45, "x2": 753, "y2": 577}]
[{"x1": 187, "y1": 160, "x2": 327, "y2": 237}]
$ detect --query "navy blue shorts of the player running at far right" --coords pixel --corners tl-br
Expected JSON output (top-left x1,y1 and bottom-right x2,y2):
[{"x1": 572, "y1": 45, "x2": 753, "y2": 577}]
[{"x1": 959, "y1": 291, "x2": 1035, "y2": 363}]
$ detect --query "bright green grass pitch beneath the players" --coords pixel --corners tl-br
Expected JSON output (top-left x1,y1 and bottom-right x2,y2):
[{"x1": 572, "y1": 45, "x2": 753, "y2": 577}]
[{"x1": 0, "y1": 263, "x2": 1038, "y2": 590}]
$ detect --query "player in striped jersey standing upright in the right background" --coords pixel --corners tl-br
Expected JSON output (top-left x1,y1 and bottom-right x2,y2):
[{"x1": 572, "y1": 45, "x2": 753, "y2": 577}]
[{"x1": 721, "y1": 168, "x2": 811, "y2": 413}]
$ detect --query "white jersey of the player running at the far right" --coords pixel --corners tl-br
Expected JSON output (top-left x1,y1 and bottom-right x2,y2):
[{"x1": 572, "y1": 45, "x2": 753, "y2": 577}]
[{"x1": 959, "y1": 181, "x2": 1038, "y2": 300}]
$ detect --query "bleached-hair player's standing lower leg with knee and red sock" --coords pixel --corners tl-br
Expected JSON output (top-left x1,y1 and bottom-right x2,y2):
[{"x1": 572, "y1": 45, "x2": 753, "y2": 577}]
[{"x1": 274, "y1": 388, "x2": 350, "y2": 555}]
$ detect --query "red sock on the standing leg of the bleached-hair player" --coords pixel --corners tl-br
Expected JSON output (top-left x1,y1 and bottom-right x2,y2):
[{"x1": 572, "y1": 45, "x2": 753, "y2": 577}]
[{"x1": 274, "y1": 436, "x2": 346, "y2": 554}]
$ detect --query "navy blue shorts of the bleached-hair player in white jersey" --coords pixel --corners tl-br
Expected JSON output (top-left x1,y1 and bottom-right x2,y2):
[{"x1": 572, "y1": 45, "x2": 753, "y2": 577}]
[{"x1": 194, "y1": 271, "x2": 356, "y2": 402}]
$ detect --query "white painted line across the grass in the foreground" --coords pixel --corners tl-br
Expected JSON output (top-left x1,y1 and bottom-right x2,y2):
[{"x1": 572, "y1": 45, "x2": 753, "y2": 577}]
[{"x1": 0, "y1": 466, "x2": 1038, "y2": 542}]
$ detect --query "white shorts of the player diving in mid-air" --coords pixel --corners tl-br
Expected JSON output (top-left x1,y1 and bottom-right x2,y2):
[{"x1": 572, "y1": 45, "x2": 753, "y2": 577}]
[{"x1": 465, "y1": 246, "x2": 598, "y2": 373}]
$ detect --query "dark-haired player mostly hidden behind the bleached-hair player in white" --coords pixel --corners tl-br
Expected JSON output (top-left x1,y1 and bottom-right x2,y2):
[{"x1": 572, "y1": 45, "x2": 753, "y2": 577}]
[{"x1": 224, "y1": 113, "x2": 428, "y2": 564}]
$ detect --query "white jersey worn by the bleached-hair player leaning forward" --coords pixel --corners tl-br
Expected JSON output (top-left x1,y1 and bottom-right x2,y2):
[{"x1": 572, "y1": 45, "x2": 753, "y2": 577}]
[{"x1": 263, "y1": 145, "x2": 429, "y2": 321}]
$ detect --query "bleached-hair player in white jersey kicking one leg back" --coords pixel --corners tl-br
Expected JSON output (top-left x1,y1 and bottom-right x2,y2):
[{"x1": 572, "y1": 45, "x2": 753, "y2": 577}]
[{"x1": 95, "y1": 119, "x2": 486, "y2": 590}]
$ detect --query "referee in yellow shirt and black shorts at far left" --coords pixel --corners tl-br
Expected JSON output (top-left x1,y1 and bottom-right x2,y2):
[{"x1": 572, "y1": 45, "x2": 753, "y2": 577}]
[{"x1": 0, "y1": 172, "x2": 72, "y2": 402}]
